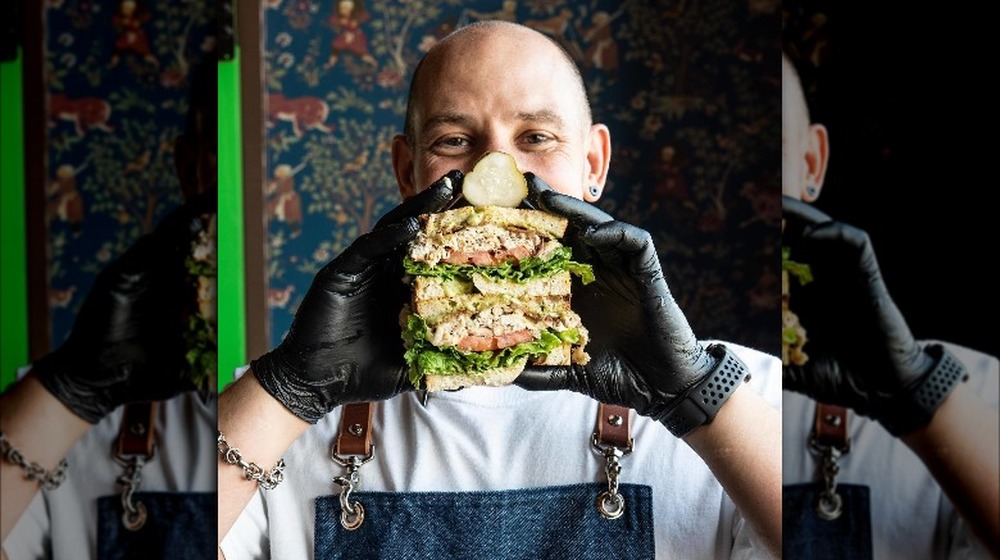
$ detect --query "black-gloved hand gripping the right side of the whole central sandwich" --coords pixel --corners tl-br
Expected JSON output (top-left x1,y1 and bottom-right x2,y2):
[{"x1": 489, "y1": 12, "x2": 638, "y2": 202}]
[{"x1": 515, "y1": 173, "x2": 745, "y2": 437}]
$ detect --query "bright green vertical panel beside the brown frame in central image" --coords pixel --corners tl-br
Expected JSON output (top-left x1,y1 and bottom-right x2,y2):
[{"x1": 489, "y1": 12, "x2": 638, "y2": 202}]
[{"x1": 218, "y1": 49, "x2": 247, "y2": 391}]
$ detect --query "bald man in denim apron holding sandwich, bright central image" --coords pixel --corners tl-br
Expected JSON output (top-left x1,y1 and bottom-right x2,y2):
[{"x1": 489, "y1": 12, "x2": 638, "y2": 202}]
[{"x1": 219, "y1": 22, "x2": 781, "y2": 560}]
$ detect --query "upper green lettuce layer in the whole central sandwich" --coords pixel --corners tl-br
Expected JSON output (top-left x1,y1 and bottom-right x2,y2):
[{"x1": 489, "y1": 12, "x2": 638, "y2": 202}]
[{"x1": 403, "y1": 247, "x2": 594, "y2": 284}]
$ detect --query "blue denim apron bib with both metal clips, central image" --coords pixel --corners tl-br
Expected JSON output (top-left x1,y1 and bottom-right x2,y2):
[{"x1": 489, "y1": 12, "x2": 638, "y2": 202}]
[{"x1": 315, "y1": 483, "x2": 654, "y2": 560}]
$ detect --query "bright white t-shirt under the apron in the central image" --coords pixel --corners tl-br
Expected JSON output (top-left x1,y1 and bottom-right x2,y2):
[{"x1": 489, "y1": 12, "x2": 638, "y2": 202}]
[{"x1": 222, "y1": 343, "x2": 781, "y2": 560}]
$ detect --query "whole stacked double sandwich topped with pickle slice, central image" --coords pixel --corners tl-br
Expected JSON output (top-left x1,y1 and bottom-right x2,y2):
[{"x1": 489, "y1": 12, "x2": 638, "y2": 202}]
[{"x1": 400, "y1": 152, "x2": 594, "y2": 391}]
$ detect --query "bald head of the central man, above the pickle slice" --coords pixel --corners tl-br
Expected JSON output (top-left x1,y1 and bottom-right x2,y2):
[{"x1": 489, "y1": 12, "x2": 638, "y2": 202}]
[{"x1": 392, "y1": 21, "x2": 611, "y2": 201}]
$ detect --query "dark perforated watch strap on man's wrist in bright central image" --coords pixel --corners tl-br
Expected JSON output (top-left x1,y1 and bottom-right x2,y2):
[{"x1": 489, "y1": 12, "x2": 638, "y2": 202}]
[{"x1": 658, "y1": 344, "x2": 750, "y2": 437}]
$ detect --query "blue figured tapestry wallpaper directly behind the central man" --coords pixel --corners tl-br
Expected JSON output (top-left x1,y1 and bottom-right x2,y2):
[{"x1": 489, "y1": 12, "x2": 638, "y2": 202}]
[{"x1": 263, "y1": 0, "x2": 781, "y2": 354}]
